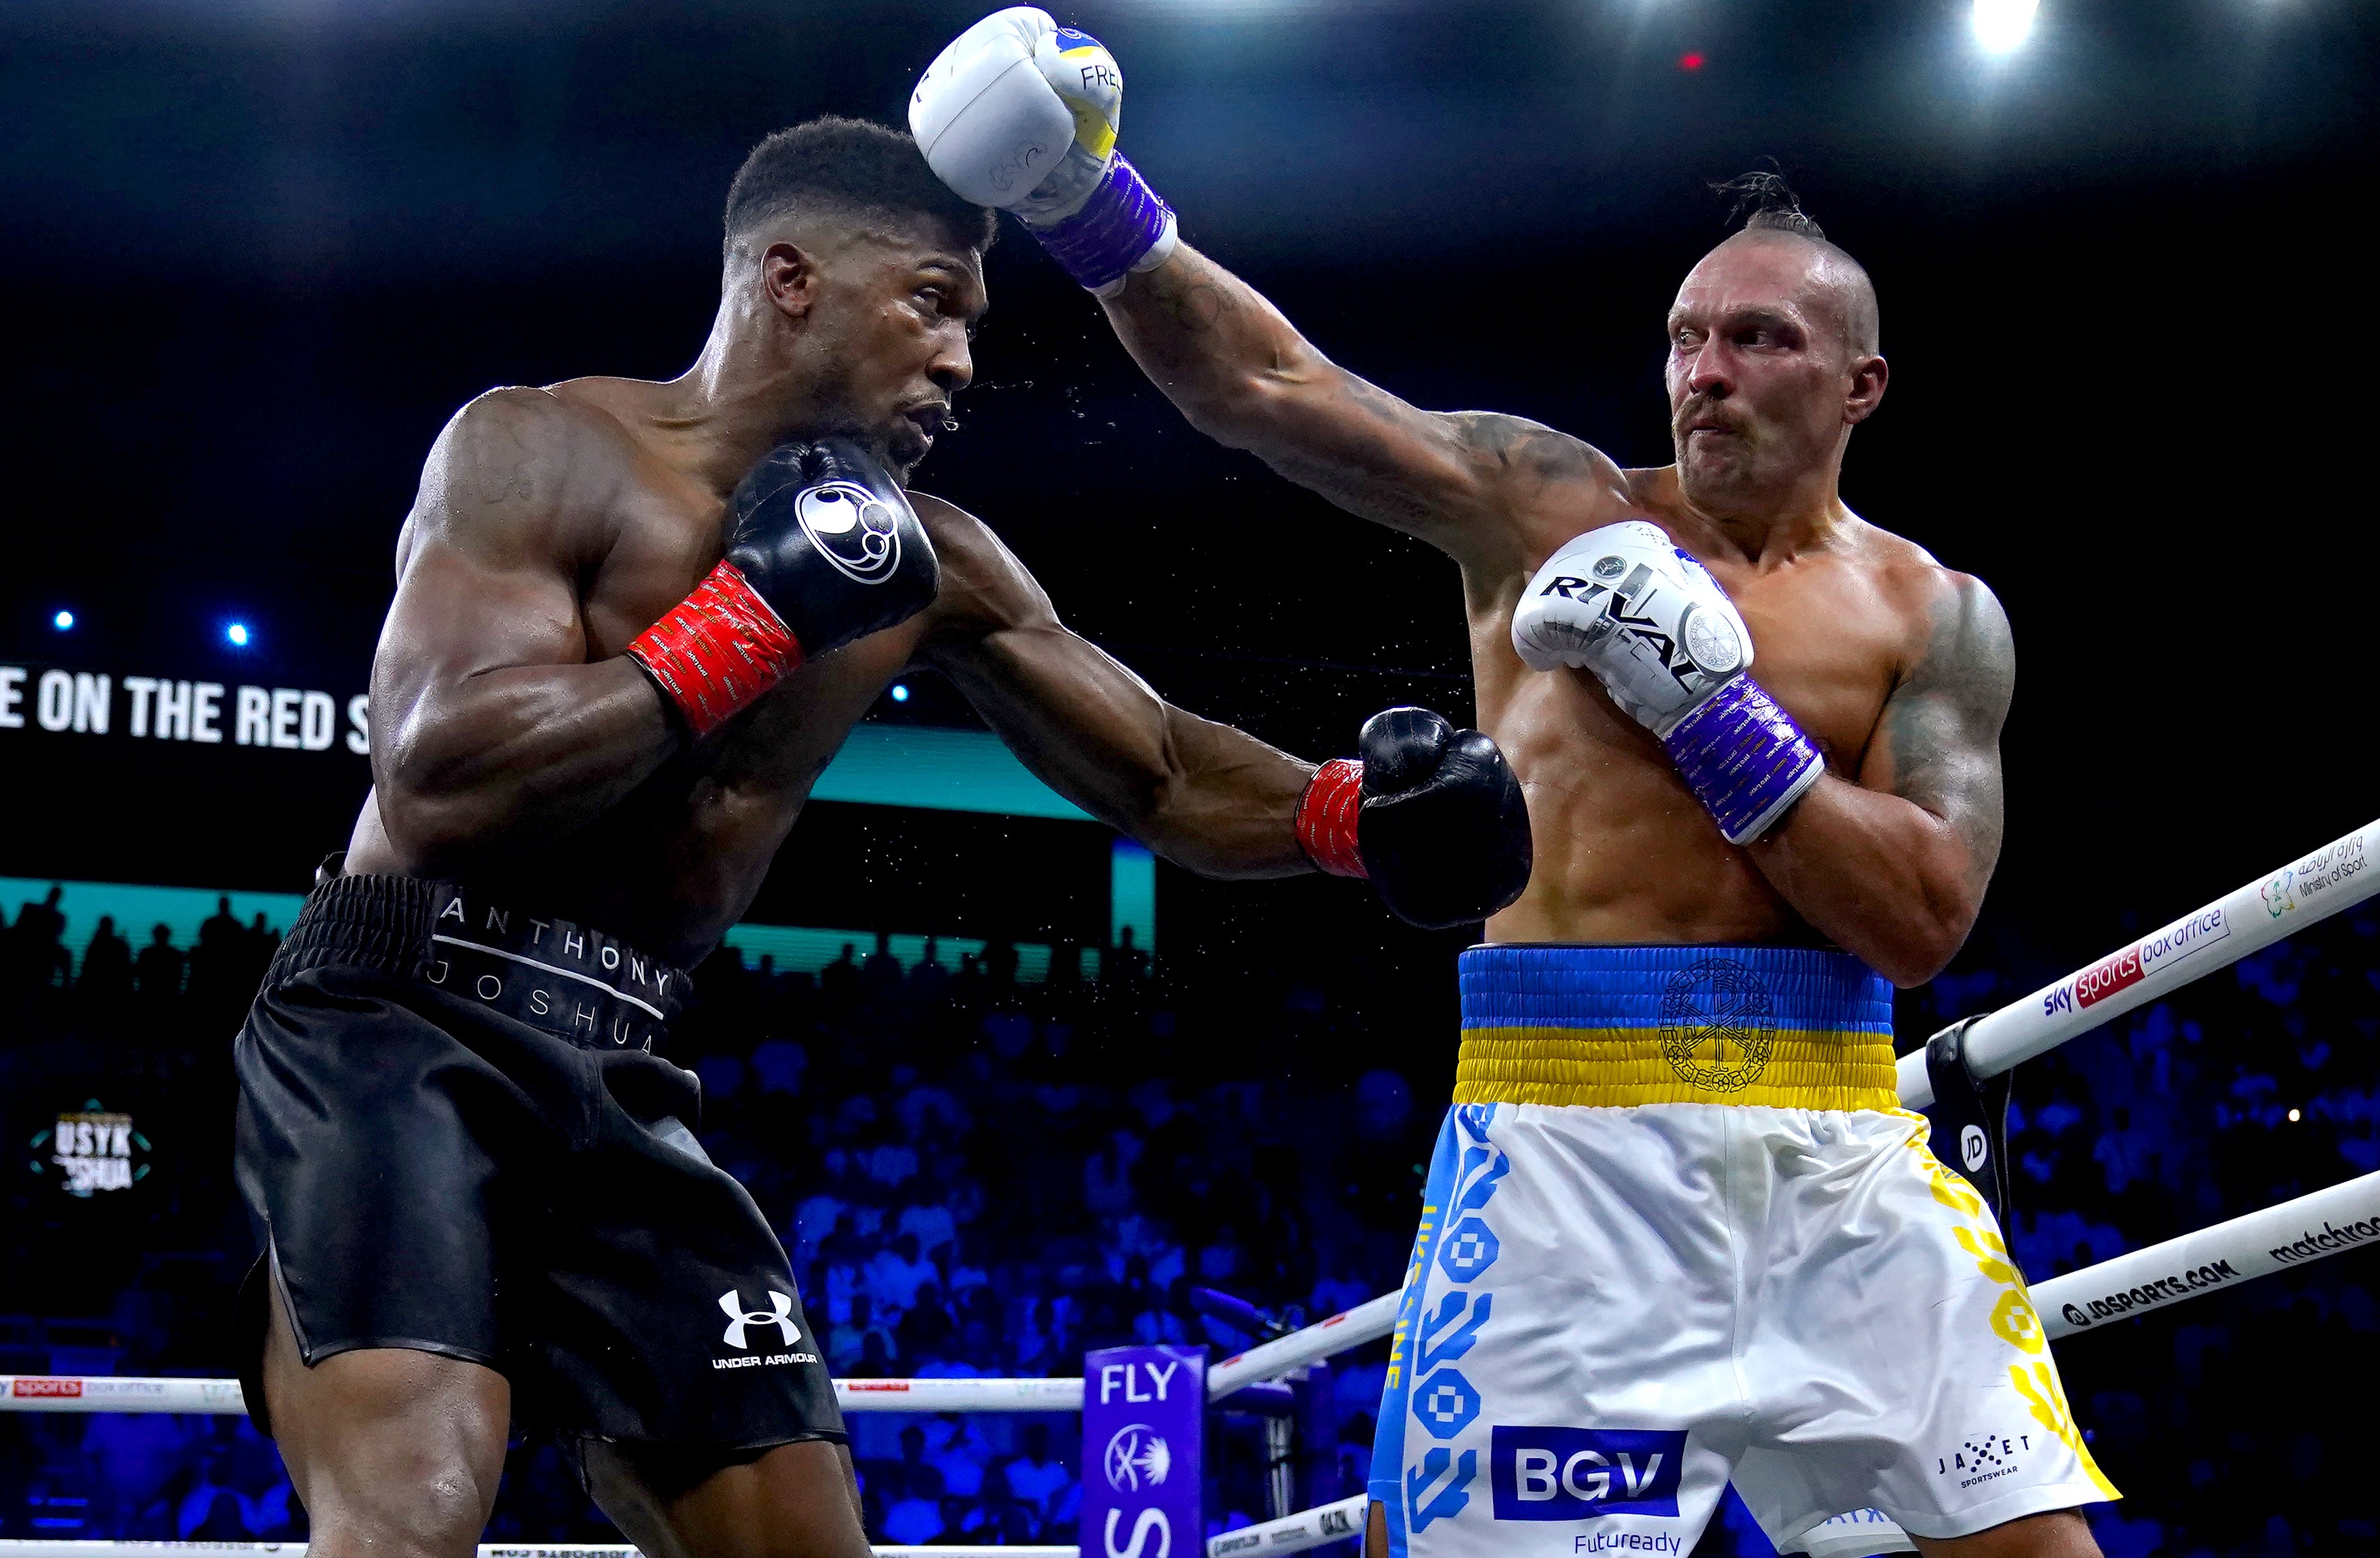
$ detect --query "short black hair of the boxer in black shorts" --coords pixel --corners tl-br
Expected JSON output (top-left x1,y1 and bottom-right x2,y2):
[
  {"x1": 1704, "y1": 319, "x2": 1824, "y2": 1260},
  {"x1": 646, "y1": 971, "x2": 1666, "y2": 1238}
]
[{"x1": 726, "y1": 114, "x2": 1000, "y2": 252}]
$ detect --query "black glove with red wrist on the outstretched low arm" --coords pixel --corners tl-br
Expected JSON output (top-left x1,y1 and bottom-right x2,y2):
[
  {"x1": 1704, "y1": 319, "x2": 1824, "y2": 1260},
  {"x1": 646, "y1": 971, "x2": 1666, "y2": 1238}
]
[{"x1": 1297, "y1": 707, "x2": 1533, "y2": 929}]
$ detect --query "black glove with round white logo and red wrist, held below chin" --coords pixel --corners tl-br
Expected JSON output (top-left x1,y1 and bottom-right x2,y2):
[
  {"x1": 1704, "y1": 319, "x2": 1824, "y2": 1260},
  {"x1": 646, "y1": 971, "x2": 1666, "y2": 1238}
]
[{"x1": 628, "y1": 438, "x2": 942, "y2": 736}]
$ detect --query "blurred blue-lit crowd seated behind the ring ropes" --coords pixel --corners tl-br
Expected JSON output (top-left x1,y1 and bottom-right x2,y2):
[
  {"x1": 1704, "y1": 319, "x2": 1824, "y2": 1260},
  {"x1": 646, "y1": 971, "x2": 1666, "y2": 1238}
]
[{"x1": 0, "y1": 903, "x2": 2380, "y2": 1558}]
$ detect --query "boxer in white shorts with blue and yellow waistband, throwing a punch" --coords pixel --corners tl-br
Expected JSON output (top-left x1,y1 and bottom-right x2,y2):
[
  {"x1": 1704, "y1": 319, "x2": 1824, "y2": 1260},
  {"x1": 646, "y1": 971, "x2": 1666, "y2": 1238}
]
[{"x1": 909, "y1": 21, "x2": 2116, "y2": 1558}]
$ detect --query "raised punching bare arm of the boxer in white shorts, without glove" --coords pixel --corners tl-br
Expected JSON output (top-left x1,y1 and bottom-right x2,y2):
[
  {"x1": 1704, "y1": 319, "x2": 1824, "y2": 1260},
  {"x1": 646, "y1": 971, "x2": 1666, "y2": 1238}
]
[{"x1": 1107, "y1": 243, "x2": 1628, "y2": 572}]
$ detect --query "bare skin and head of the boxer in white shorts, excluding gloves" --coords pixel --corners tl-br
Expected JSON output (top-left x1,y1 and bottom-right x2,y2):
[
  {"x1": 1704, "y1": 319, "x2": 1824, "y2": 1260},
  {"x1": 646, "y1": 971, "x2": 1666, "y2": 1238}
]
[{"x1": 1107, "y1": 199, "x2": 2097, "y2": 1558}]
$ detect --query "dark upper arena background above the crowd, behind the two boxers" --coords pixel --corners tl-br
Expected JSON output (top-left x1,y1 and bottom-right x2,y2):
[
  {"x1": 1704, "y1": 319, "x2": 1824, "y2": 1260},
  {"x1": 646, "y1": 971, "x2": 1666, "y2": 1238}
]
[{"x1": 0, "y1": 0, "x2": 2380, "y2": 1024}]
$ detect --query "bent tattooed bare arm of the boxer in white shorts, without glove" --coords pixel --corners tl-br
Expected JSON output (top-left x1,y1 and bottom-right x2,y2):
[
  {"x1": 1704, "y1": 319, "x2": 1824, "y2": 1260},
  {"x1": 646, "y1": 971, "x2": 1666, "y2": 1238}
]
[{"x1": 1749, "y1": 574, "x2": 2016, "y2": 986}]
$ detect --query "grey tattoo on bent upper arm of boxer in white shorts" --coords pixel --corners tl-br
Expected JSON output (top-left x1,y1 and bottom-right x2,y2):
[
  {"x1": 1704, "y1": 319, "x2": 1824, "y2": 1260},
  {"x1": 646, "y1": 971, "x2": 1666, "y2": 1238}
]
[{"x1": 1883, "y1": 579, "x2": 2016, "y2": 881}]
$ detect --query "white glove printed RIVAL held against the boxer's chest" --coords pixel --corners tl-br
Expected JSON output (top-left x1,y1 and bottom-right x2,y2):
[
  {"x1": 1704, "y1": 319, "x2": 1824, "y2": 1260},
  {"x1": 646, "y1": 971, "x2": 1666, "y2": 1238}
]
[{"x1": 1511, "y1": 520, "x2": 1825, "y2": 844}]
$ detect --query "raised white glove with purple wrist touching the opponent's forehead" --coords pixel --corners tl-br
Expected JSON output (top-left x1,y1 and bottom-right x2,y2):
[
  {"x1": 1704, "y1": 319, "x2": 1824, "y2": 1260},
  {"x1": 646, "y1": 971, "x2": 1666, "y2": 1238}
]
[{"x1": 909, "y1": 5, "x2": 1176, "y2": 298}]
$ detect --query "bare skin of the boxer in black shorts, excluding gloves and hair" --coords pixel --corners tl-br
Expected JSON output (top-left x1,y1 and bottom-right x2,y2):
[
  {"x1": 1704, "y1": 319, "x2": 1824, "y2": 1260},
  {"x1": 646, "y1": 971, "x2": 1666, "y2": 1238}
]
[{"x1": 262, "y1": 126, "x2": 1526, "y2": 1558}]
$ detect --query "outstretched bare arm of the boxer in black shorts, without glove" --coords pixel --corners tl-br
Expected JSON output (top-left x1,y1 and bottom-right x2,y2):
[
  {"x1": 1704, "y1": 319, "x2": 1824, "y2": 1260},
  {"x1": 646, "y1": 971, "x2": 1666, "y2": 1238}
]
[{"x1": 914, "y1": 495, "x2": 1314, "y2": 877}]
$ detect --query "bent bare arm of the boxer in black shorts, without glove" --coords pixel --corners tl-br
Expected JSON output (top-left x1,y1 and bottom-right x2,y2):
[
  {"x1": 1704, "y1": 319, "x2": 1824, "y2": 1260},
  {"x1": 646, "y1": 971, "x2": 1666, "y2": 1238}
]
[{"x1": 371, "y1": 390, "x2": 676, "y2": 872}]
